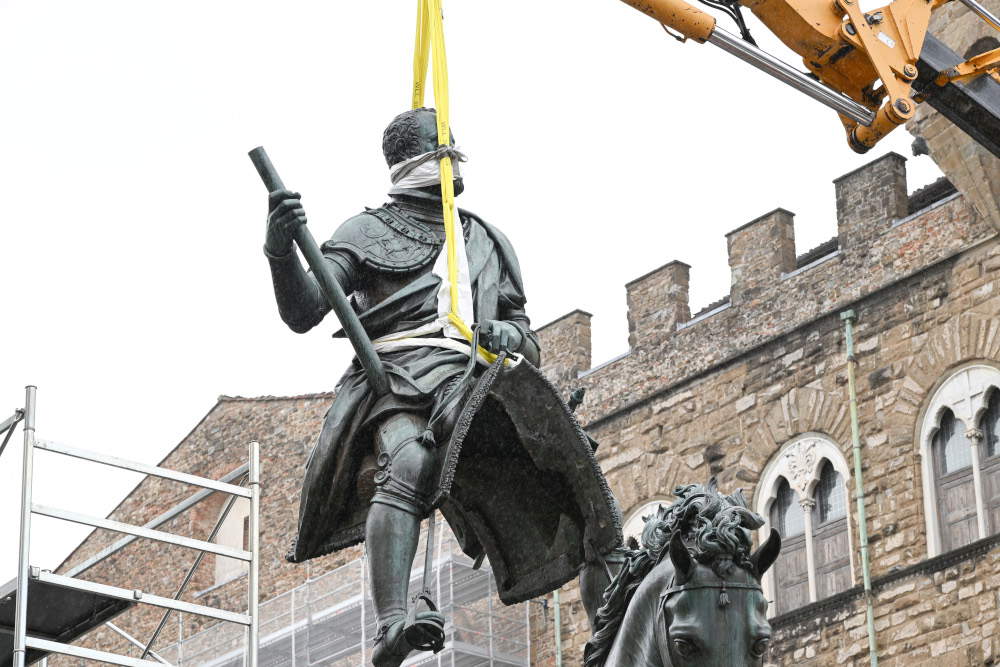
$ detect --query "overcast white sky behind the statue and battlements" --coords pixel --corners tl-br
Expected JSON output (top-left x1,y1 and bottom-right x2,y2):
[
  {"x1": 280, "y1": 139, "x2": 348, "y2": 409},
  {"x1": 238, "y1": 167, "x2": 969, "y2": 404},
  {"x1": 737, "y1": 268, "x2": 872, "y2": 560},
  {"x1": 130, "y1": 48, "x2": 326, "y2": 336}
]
[{"x1": 0, "y1": 0, "x2": 939, "y2": 582}]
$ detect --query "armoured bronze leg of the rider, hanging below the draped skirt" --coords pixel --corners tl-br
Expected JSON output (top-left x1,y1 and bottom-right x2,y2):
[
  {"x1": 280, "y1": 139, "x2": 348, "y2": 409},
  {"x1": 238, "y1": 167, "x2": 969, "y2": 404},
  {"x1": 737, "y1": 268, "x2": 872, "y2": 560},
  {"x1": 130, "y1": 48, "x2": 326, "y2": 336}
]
[{"x1": 365, "y1": 412, "x2": 444, "y2": 667}]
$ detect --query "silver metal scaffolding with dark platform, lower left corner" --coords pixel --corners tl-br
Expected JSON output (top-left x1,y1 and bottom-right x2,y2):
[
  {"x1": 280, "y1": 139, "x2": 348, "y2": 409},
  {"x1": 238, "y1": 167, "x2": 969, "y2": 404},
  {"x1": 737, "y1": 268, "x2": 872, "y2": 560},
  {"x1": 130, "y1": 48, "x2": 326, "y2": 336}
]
[{"x1": 0, "y1": 386, "x2": 260, "y2": 667}]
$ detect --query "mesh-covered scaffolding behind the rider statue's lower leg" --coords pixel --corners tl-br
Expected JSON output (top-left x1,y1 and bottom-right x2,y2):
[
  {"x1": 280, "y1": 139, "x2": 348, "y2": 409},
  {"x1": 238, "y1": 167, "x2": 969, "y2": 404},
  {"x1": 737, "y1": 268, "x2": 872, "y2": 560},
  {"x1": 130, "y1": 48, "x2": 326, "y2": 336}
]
[{"x1": 160, "y1": 522, "x2": 531, "y2": 667}]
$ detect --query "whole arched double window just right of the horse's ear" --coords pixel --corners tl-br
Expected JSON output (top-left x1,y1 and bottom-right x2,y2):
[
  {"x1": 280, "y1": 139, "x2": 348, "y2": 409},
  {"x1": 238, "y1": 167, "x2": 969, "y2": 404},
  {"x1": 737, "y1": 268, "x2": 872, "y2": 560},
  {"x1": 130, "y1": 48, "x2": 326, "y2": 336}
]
[{"x1": 754, "y1": 433, "x2": 854, "y2": 614}]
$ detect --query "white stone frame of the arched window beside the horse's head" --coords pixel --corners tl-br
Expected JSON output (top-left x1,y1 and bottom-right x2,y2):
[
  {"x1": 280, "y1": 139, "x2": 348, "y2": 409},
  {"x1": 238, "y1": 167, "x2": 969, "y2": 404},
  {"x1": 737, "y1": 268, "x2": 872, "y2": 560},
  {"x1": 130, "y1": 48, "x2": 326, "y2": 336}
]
[{"x1": 753, "y1": 431, "x2": 858, "y2": 617}]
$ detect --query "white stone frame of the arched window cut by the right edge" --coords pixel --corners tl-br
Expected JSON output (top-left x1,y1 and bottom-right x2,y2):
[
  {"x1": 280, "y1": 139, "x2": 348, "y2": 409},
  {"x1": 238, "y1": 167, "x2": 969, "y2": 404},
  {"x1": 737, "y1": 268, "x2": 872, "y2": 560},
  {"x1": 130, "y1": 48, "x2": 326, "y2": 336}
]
[{"x1": 917, "y1": 359, "x2": 1000, "y2": 558}]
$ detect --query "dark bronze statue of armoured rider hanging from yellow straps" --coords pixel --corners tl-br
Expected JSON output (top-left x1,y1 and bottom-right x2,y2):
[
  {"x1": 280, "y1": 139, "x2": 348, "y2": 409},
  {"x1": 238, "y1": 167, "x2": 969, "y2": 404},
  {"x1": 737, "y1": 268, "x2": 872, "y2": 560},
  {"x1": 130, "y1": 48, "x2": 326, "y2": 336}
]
[{"x1": 264, "y1": 109, "x2": 620, "y2": 667}]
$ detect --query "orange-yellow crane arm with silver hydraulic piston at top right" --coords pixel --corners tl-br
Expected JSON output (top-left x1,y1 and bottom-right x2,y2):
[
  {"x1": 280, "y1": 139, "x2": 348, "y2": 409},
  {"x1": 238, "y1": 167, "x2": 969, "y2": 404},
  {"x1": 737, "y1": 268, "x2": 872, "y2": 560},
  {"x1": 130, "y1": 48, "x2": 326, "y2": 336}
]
[{"x1": 623, "y1": 0, "x2": 1000, "y2": 153}]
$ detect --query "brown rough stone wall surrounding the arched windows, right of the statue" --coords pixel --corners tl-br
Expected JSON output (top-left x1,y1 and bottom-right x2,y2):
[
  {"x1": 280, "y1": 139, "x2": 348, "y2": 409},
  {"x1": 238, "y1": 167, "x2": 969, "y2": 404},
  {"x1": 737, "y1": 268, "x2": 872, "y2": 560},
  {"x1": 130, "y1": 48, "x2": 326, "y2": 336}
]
[{"x1": 533, "y1": 154, "x2": 1000, "y2": 666}]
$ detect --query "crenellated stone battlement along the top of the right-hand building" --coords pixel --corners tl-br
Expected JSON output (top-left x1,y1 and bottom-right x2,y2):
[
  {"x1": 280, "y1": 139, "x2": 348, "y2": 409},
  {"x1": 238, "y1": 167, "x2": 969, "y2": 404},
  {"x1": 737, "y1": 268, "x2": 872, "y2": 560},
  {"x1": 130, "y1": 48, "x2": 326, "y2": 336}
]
[{"x1": 539, "y1": 153, "x2": 995, "y2": 423}]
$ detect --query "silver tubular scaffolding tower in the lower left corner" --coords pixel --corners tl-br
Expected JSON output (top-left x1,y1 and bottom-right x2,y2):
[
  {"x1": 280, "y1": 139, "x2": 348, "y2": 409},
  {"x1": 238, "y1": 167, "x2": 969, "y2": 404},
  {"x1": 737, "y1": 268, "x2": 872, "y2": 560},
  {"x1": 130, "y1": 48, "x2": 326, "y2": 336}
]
[{"x1": 9, "y1": 385, "x2": 260, "y2": 667}]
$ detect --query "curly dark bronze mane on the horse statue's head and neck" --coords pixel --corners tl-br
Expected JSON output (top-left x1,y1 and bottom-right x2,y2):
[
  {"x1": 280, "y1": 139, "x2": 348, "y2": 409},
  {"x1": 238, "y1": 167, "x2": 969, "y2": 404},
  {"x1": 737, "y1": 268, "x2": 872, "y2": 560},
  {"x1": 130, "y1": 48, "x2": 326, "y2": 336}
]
[{"x1": 584, "y1": 478, "x2": 764, "y2": 667}]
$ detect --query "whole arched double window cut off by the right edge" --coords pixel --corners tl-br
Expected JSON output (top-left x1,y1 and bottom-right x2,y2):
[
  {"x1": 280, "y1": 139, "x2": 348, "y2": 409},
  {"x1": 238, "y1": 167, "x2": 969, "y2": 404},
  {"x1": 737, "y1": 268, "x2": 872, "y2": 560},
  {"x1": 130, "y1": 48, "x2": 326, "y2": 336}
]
[{"x1": 920, "y1": 362, "x2": 1000, "y2": 556}]
